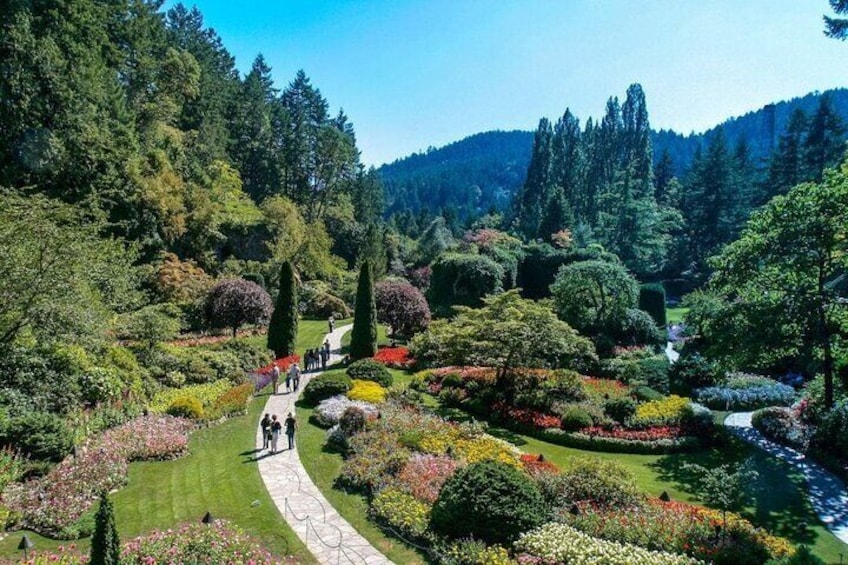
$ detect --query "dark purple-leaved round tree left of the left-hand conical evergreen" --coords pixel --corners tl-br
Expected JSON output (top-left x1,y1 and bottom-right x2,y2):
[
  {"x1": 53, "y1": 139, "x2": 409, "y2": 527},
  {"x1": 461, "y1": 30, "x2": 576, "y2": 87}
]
[{"x1": 205, "y1": 279, "x2": 272, "y2": 337}]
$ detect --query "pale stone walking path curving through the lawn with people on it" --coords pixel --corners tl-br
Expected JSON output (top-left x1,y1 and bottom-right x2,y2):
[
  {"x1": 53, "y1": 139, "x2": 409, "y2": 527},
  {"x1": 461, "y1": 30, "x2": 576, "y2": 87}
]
[{"x1": 256, "y1": 325, "x2": 391, "y2": 565}]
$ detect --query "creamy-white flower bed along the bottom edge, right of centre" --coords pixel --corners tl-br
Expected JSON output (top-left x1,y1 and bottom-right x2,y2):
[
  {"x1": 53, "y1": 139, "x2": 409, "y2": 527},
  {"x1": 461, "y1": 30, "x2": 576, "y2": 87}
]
[{"x1": 516, "y1": 523, "x2": 703, "y2": 565}]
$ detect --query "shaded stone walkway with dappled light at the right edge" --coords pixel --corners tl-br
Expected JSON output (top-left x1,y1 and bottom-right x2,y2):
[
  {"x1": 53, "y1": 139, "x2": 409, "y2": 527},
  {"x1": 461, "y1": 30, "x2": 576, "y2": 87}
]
[{"x1": 724, "y1": 412, "x2": 848, "y2": 543}]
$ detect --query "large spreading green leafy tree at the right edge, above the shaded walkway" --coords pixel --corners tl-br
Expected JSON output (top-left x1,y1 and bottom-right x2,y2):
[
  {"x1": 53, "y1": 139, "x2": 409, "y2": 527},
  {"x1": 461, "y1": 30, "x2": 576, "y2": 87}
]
[{"x1": 691, "y1": 164, "x2": 848, "y2": 407}]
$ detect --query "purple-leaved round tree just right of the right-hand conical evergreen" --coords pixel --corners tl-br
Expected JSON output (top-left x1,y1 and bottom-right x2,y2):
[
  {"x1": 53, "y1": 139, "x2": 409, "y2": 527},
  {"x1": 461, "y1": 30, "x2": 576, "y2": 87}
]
[{"x1": 375, "y1": 281, "x2": 430, "y2": 339}]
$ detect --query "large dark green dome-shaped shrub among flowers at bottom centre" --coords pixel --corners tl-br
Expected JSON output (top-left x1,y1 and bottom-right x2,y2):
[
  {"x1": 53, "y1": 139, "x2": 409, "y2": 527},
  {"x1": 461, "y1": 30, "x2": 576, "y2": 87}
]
[{"x1": 430, "y1": 461, "x2": 547, "y2": 543}]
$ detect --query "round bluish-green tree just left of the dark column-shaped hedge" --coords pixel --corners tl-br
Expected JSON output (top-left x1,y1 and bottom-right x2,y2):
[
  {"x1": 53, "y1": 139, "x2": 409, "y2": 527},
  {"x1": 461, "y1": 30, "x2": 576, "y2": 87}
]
[{"x1": 551, "y1": 260, "x2": 639, "y2": 335}]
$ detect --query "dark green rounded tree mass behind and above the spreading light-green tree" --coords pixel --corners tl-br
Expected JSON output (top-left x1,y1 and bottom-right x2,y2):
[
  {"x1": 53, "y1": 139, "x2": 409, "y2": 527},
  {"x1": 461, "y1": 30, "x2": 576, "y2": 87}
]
[{"x1": 427, "y1": 253, "x2": 504, "y2": 316}]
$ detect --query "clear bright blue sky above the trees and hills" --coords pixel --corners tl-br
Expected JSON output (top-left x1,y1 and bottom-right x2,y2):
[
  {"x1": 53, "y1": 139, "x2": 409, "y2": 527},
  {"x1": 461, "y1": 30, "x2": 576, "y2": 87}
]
[{"x1": 165, "y1": 0, "x2": 848, "y2": 166}]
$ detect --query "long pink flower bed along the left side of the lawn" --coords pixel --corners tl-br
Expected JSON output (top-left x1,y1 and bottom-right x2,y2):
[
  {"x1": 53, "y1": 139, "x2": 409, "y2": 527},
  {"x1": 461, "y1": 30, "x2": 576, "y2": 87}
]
[{"x1": 3, "y1": 415, "x2": 194, "y2": 539}]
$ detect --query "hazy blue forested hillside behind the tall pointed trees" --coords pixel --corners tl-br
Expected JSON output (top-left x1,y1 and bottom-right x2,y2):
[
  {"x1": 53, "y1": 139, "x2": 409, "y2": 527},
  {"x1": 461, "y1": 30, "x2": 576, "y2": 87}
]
[{"x1": 379, "y1": 89, "x2": 848, "y2": 217}]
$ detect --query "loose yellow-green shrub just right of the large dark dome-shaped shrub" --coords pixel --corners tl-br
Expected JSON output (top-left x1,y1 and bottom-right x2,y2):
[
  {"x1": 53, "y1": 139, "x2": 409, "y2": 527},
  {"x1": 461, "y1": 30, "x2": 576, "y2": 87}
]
[{"x1": 537, "y1": 457, "x2": 642, "y2": 509}]
